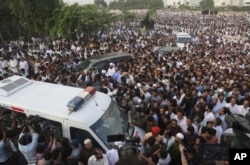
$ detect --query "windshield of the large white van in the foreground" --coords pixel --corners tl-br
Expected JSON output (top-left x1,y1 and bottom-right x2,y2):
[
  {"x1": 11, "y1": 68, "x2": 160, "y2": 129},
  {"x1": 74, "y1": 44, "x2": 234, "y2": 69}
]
[{"x1": 90, "y1": 101, "x2": 128, "y2": 148}]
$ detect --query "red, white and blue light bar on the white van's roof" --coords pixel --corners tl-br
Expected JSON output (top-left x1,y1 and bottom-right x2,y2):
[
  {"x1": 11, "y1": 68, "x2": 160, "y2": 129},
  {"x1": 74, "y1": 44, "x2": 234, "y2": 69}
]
[{"x1": 67, "y1": 87, "x2": 96, "y2": 111}]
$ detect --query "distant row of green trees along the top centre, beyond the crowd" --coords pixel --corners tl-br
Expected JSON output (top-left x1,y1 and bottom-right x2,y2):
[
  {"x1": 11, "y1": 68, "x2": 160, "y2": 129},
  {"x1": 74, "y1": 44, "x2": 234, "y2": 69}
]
[{"x1": 109, "y1": 0, "x2": 164, "y2": 10}]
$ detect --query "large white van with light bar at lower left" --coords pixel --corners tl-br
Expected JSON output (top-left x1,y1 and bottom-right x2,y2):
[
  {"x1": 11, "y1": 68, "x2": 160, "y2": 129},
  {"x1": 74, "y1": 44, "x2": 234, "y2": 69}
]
[{"x1": 0, "y1": 76, "x2": 145, "y2": 151}]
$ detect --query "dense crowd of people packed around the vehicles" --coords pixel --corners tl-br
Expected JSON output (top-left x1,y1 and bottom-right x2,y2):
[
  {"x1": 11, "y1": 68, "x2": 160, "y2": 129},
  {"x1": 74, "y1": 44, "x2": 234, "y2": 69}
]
[{"x1": 0, "y1": 12, "x2": 250, "y2": 165}]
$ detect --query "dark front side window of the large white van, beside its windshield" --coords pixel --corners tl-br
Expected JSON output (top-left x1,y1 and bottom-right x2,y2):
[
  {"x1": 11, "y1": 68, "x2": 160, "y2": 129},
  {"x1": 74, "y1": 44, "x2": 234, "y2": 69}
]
[{"x1": 69, "y1": 127, "x2": 104, "y2": 150}]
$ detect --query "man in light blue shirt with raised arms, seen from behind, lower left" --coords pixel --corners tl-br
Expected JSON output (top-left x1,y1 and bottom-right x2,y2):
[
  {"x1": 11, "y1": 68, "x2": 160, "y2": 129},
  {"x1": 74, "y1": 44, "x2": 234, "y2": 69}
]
[{"x1": 18, "y1": 126, "x2": 38, "y2": 165}]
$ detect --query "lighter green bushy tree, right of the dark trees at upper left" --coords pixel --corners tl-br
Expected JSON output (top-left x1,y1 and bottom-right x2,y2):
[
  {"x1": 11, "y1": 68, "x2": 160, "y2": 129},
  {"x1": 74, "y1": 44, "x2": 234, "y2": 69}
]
[{"x1": 50, "y1": 3, "x2": 114, "y2": 38}]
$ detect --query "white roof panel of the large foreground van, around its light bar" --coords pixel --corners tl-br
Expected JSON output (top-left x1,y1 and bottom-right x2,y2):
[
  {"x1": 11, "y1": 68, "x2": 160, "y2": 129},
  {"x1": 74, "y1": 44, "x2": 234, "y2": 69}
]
[{"x1": 0, "y1": 76, "x2": 111, "y2": 127}]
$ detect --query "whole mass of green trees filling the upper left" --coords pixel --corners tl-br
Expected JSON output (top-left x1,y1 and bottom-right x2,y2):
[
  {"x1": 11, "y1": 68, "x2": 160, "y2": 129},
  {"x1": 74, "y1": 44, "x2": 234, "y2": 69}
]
[{"x1": 0, "y1": 0, "x2": 114, "y2": 41}]
